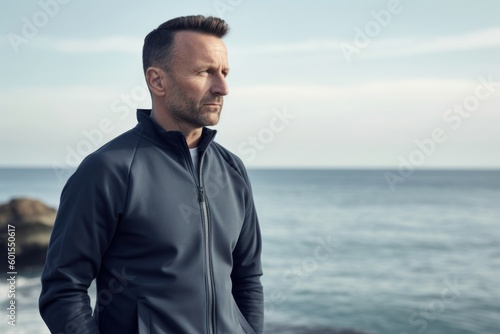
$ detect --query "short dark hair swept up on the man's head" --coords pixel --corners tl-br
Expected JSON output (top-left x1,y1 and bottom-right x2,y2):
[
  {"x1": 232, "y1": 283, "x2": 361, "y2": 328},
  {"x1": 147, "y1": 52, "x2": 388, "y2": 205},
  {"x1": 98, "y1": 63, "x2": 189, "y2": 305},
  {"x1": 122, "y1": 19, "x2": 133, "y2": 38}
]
[{"x1": 142, "y1": 15, "x2": 229, "y2": 73}]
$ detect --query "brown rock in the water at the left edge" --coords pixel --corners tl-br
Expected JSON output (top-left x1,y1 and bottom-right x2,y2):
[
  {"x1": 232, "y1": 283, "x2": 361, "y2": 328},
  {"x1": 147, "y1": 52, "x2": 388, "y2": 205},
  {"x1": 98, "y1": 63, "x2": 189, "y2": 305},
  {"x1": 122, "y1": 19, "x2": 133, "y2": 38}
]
[{"x1": 0, "y1": 198, "x2": 56, "y2": 273}]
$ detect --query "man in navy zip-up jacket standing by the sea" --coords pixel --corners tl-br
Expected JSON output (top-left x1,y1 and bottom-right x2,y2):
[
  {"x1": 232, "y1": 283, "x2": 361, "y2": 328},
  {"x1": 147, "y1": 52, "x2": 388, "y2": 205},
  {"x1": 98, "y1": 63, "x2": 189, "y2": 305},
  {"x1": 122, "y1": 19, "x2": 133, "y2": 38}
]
[{"x1": 40, "y1": 16, "x2": 263, "y2": 334}]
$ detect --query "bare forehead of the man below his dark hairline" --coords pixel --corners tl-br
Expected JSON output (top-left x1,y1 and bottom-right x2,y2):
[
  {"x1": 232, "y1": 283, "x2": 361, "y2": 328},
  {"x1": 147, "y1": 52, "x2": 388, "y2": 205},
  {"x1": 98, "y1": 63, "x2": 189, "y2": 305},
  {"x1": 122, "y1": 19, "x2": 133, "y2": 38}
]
[{"x1": 174, "y1": 31, "x2": 227, "y2": 65}]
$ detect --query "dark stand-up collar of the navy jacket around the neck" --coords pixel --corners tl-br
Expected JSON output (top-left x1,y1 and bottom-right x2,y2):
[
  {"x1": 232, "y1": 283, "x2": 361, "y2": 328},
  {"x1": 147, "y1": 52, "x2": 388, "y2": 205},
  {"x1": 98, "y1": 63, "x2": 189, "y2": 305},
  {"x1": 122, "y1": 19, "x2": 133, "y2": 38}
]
[{"x1": 135, "y1": 109, "x2": 217, "y2": 152}]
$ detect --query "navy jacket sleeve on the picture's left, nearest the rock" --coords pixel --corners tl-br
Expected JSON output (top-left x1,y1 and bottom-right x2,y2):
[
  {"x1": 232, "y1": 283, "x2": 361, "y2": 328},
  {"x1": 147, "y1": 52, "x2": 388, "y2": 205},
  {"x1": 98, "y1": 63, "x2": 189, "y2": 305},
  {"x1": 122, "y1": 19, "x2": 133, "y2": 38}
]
[{"x1": 39, "y1": 154, "x2": 126, "y2": 334}]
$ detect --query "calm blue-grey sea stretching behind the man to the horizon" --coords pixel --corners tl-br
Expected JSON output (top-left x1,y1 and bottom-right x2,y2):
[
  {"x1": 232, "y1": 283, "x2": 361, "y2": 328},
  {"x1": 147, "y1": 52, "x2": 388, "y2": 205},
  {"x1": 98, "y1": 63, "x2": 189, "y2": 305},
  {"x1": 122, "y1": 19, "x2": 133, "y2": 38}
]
[{"x1": 0, "y1": 168, "x2": 500, "y2": 334}]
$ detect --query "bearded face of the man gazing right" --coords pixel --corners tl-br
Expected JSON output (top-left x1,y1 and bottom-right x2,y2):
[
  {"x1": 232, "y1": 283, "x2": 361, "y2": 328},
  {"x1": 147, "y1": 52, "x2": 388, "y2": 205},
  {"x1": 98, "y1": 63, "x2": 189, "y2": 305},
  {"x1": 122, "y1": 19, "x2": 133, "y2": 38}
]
[{"x1": 165, "y1": 31, "x2": 229, "y2": 128}]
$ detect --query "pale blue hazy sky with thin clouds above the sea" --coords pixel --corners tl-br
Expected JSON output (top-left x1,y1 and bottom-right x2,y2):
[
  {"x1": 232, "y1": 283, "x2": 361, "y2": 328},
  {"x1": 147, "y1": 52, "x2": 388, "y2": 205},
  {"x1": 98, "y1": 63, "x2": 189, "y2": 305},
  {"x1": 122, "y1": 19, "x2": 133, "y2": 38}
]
[{"x1": 0, "y1": 0, "x2": 500, "y2": 171}]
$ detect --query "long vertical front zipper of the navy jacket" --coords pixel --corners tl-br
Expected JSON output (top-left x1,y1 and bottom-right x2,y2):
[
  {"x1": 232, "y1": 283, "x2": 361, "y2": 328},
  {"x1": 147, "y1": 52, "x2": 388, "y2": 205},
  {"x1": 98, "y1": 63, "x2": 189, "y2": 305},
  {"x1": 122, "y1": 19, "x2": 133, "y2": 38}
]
[{"x1": 198, "y1": 154, "x2": 215, "y2": 334}]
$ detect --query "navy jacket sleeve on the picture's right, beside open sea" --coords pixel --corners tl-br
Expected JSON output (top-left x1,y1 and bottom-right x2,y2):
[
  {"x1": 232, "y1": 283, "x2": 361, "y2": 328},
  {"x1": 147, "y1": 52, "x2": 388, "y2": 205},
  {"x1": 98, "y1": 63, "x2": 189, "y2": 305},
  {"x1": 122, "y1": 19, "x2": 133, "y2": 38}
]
[{"x1": 231, "y1": 169, "x2": 264, "y2": 334}]
